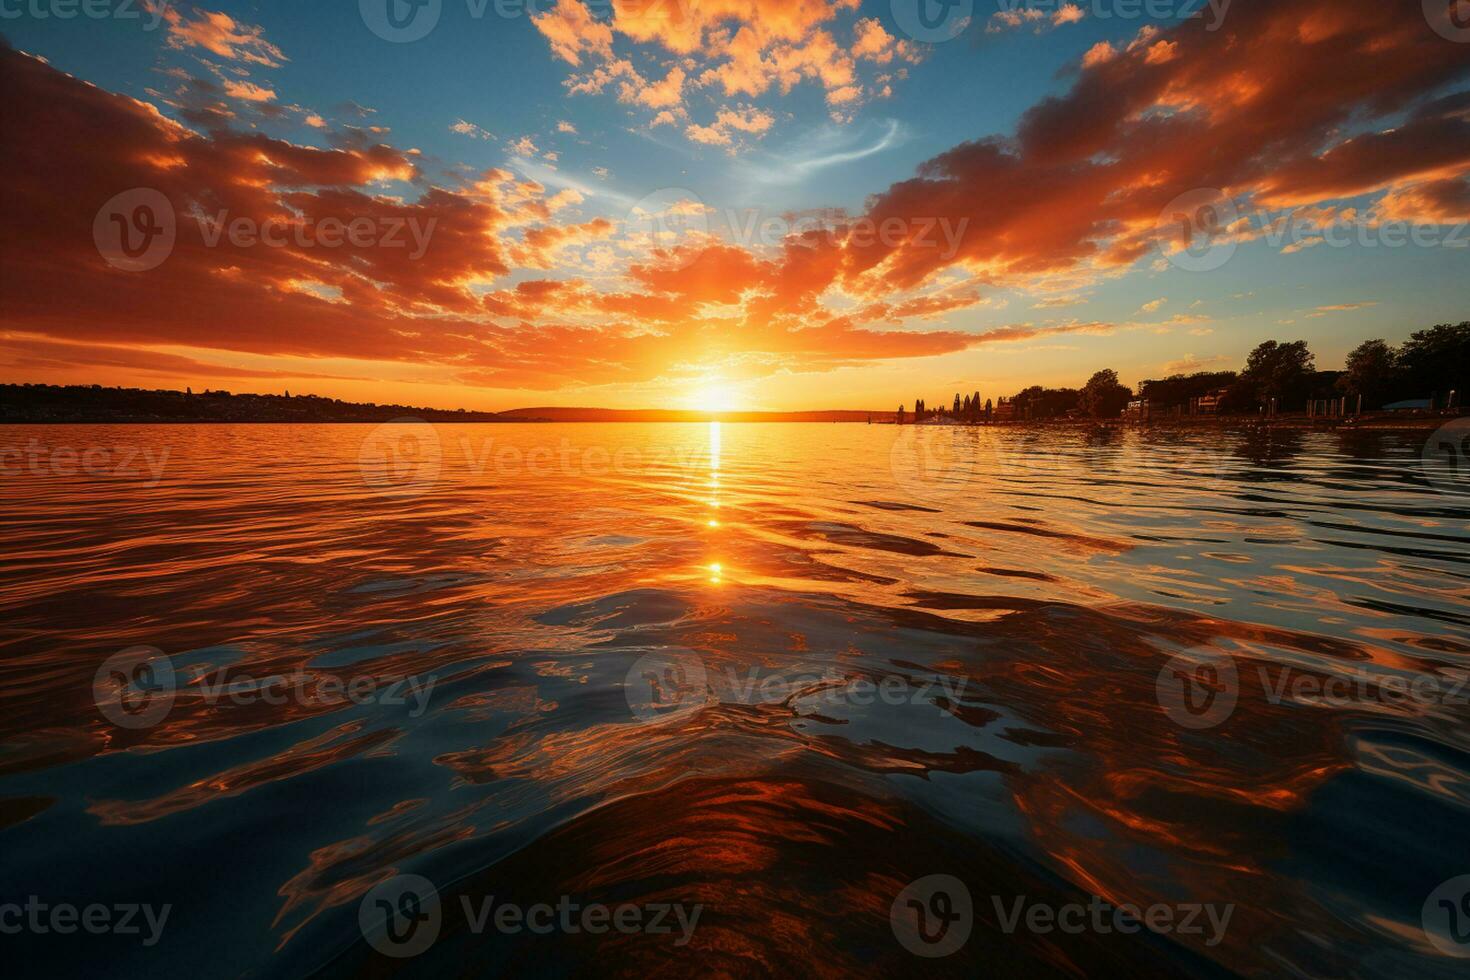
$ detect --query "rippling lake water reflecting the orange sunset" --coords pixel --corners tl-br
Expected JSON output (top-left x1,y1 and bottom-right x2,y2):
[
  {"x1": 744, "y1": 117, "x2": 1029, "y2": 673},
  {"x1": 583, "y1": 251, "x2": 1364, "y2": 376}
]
[{"x1": 0, "y1": 425, "x2": 1470, "y2": 977}]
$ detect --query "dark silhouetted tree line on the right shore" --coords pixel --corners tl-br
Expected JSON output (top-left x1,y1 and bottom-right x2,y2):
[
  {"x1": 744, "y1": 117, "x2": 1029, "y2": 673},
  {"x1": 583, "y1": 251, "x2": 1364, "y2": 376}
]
[{"x1": 898, "y1": 320, "x2": 1470, "y2": 422}]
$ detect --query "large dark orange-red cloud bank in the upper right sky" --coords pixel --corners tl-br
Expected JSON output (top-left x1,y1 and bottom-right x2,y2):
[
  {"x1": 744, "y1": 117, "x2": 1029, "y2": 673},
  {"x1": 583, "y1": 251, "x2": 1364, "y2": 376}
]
[{"x1": 850, "y1": 0, "x2": 1470, "y2": 295}]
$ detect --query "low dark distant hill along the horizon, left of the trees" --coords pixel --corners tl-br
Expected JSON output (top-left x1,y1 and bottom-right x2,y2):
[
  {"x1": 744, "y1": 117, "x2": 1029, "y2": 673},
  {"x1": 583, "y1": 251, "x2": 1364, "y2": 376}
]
[{"x1": 0, "y1": 385, "x2": 894, "y2": 425}]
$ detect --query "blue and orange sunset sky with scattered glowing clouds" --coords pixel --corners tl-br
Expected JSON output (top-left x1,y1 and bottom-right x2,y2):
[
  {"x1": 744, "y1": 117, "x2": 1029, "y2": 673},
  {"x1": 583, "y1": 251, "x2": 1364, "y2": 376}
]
[{"x1": 0, "y1": 0, "x2": 1470, "y2": 410}]
